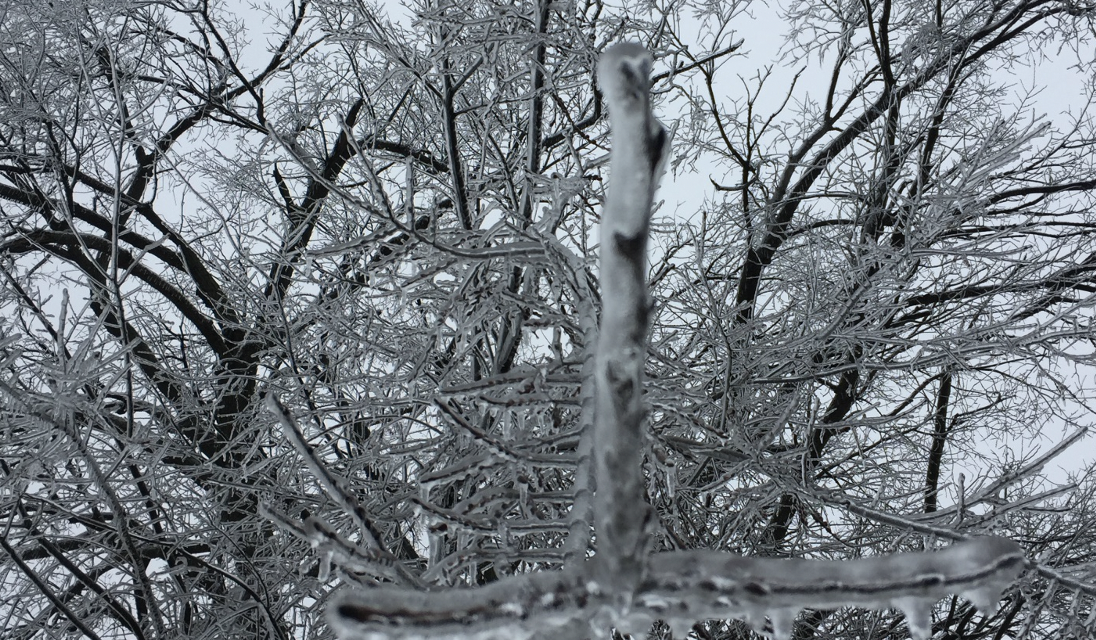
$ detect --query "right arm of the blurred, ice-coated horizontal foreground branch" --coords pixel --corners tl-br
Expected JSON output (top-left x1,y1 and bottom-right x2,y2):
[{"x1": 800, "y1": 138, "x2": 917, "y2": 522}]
[{"x1": 636, "y1": 536, "x2": 1026, "y2": 639}]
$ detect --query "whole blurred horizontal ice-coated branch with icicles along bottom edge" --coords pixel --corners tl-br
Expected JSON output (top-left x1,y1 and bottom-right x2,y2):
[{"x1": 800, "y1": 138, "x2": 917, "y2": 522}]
[{"x1": 331, "y1": 537, "x2": 1026, "y2": 640}]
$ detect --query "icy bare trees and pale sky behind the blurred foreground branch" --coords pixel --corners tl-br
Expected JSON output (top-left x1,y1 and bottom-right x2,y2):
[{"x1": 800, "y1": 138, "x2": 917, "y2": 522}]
[{"x1": 0, "y1": 0, "x2": 1096, "y2": 640}]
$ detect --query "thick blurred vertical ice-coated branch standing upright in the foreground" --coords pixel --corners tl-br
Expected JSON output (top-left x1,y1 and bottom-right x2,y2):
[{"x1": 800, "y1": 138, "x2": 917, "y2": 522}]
[{"x1": 594, "y1": 44, "x2": 667, "y2": 597}]
